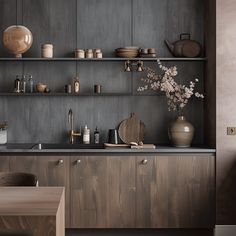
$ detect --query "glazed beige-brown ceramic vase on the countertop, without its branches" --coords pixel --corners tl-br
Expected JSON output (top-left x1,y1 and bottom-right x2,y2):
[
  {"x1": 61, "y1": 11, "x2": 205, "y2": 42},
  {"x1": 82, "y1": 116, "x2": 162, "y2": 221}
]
[{"x1": 168, "y1": 116, "x2": 194, "y2": 147}]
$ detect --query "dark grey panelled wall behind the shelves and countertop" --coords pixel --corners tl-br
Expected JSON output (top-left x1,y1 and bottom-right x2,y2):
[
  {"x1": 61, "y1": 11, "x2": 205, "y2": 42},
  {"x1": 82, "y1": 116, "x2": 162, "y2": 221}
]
[{"x1": 0, "y1": 0, "x2": 204, "y2": 143}]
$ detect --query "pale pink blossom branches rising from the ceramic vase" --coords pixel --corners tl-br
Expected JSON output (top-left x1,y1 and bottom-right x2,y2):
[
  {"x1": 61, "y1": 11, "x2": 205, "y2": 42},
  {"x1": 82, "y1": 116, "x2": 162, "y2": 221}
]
[{"x1": 138, "y1": 59, "x2": 204, "y2": 112}]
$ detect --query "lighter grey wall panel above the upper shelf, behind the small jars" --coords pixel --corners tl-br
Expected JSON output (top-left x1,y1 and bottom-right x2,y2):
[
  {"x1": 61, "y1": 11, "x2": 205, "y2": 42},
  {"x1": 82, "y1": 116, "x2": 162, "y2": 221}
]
[{"x1": 77, "y1": 0, "x2": 131, "y2": 56}]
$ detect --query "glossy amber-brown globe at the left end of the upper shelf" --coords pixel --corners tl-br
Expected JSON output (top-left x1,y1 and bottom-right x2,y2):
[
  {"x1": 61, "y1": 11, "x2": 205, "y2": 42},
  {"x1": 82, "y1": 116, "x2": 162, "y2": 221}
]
[{"x1": 3, "y1": 25, "x2": 33, "y2": 57}]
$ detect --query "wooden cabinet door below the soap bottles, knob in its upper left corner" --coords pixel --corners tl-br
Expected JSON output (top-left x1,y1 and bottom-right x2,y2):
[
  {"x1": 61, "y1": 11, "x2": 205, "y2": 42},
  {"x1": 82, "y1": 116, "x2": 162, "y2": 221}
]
[{"x1": 70, "y1": 156, "x2": 135, "y2": 228}]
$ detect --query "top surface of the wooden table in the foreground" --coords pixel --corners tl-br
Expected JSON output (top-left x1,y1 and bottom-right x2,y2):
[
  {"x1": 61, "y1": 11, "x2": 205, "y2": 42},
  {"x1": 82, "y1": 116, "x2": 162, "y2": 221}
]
[{"x1": 0, "y1": 187, "x2": 64, "y2": 216}]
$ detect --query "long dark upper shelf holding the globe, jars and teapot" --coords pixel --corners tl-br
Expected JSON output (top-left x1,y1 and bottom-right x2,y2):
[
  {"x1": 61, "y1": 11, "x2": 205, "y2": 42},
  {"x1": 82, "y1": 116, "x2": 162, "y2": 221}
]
[{"x1": 0, "y1": 57, "x2": 207, "y2": 62}]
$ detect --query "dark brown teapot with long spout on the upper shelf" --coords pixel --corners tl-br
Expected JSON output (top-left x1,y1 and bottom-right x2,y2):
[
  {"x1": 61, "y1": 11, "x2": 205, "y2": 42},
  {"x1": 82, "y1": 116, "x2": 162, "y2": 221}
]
[{"x1": 165, "y1": 33, "x2": 202, "y2": 57}]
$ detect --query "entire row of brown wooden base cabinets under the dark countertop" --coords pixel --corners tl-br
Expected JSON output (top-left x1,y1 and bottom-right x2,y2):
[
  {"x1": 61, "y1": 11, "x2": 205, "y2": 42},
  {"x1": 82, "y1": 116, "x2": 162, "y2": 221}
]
[{"x1": 0, "y1": 154, "x2": 215, "y2": 228}]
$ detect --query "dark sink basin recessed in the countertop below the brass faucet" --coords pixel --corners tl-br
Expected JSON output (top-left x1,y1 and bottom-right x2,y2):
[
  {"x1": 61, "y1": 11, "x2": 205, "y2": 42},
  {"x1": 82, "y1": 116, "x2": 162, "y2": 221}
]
[{"x1": 7, "y1": 143, "x2": 104, "y2": 150}]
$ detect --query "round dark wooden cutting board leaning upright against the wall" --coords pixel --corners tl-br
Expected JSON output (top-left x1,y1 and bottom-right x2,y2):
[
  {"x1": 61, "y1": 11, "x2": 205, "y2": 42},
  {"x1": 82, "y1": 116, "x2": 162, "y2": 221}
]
[{"x1": 118, "y1": 113, "x2": 145, "y2": 144}]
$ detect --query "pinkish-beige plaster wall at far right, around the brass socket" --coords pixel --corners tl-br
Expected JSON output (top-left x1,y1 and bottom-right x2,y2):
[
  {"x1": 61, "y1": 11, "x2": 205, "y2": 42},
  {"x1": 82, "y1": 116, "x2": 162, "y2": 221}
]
[{"x1": 216, "y1": 0, "x2": 236, "y2": 224}]
